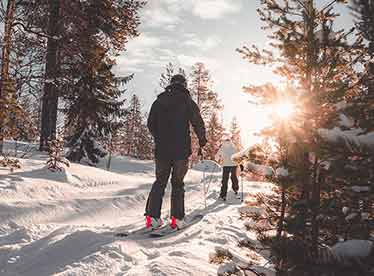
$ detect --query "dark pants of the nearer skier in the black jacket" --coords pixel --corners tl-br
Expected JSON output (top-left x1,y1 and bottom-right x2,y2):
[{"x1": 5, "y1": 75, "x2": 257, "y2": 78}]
[{"x1": 145, "y1": 160, "x2": 188, "y2": 219}]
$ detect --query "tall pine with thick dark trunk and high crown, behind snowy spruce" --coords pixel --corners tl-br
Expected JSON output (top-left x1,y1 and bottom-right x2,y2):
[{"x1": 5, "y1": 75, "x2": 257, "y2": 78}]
[{"x1": 35, "y1": 0, "x2": 145, "y2": 150}]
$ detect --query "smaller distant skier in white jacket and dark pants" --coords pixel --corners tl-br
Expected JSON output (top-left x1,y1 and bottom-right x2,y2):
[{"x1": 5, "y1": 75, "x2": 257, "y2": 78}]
[{"x1": 216, "y1": 135, "x2": 242, "y2": 201}]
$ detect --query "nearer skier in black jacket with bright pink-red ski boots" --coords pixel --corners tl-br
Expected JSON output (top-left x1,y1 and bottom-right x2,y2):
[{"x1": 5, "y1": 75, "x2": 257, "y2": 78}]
[{"x1": 145, "y1": 75, "x2": 207, "y2": 229}]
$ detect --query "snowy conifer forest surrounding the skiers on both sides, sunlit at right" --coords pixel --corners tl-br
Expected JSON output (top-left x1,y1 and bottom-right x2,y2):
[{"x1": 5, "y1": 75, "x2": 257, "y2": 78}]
[{"x1": 0, "y1": 0, "x2": 374, "y2": 276}]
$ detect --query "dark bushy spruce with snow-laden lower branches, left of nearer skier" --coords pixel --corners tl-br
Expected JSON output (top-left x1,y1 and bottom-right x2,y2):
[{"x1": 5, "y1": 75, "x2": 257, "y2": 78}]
[{"x1": 65, "y1": 44, "x2": 131, "y2": 164}]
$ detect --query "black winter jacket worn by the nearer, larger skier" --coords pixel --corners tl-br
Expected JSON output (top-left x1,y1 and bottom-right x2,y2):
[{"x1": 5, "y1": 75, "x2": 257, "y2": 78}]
[{"x1": 148, "y1": 84, "x2": 207, "y2": 160}]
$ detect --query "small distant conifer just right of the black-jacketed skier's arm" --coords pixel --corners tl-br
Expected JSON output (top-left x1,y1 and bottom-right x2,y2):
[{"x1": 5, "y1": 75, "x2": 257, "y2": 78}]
[{"x1": 205, "y1": 113, "x2": 224, "y2": 160}]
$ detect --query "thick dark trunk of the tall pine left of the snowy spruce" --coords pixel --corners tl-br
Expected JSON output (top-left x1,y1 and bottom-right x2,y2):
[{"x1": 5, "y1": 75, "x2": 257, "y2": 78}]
[{"x1": 39, "y1": 0, "x2": 60, "y2": 151}]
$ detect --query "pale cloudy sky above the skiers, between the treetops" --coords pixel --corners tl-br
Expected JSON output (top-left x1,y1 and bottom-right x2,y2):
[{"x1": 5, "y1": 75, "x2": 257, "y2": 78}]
[{"x1": 115, "y1": 0, "x2": 353, "y2": 145}]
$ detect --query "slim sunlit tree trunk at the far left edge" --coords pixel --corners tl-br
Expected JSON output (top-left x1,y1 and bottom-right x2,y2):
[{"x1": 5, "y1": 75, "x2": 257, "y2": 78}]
[{"x1": 0, "y1": 0, "x2": 16, "y2": 154}]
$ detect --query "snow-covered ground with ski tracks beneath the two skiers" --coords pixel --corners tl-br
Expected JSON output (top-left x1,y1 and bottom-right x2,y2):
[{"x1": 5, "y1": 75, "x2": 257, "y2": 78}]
[{"x1": 0, "y1": 156, "x2": 270, "y2": 276}]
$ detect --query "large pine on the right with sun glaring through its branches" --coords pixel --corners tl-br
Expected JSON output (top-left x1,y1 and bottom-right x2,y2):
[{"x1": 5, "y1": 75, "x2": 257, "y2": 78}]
[{"x1": 239, "y1": 0, "x2": 361, "y2": 269}]
